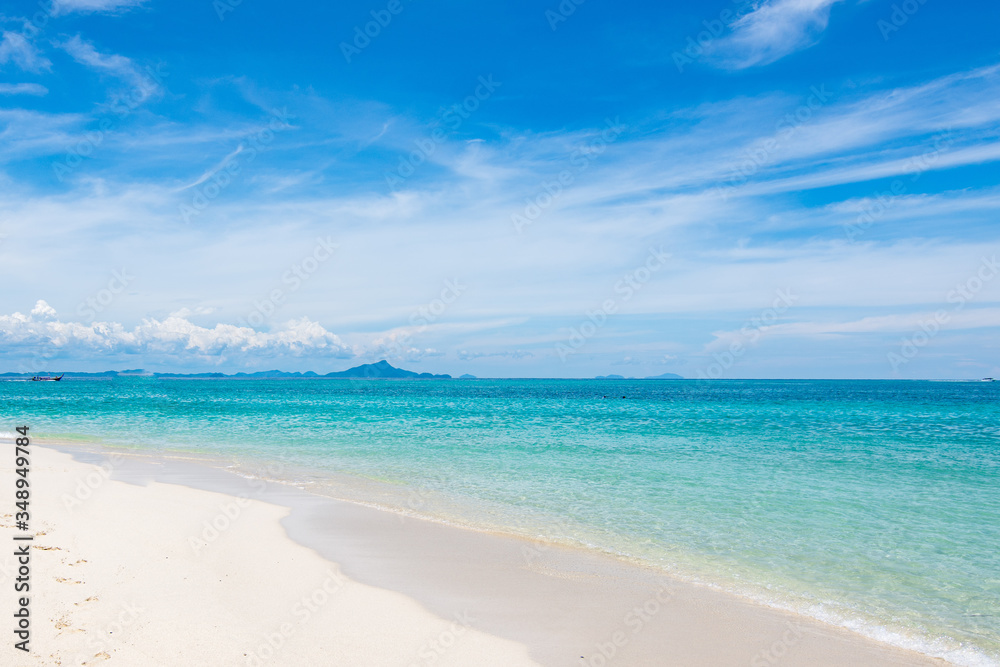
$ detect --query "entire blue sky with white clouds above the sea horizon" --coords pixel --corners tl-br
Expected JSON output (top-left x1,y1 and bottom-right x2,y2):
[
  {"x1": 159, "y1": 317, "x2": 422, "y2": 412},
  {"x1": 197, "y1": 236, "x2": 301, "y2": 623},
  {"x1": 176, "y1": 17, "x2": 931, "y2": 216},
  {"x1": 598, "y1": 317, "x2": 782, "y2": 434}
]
[{"x1": 0, "y1": 0, "x2": 1000, "y2": 379}]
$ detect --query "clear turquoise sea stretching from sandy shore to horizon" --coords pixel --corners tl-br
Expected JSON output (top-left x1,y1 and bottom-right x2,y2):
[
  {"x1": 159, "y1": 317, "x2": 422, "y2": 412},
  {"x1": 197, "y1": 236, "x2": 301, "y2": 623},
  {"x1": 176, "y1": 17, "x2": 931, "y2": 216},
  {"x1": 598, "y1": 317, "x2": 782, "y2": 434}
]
[{"x1": 0, "y1": 378, "x2": 1000, "y2": 665}]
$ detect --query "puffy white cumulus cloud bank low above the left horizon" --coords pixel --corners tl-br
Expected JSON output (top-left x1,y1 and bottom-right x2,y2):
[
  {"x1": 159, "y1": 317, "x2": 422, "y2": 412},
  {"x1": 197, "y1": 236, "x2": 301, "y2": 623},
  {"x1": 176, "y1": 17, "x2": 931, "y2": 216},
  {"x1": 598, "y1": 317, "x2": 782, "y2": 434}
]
[{"x1": 0, "y1": 301, "x2": 354, "y2": 362}]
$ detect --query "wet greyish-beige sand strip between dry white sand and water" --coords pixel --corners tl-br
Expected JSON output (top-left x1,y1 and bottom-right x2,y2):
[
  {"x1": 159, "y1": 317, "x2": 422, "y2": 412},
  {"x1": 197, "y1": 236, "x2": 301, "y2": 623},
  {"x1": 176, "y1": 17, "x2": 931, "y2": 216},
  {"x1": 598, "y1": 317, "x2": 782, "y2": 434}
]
[{"x1": 1, "y1": 443, "x2": 946, "y2": 667}]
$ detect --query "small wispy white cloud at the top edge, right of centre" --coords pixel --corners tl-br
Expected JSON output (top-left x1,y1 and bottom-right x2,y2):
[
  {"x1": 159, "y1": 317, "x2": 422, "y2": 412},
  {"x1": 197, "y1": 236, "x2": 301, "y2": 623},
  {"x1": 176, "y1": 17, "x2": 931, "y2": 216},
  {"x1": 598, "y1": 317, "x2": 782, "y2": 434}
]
[{"x1": 713, "y1": 0, "x2": 840, "y2": 69}]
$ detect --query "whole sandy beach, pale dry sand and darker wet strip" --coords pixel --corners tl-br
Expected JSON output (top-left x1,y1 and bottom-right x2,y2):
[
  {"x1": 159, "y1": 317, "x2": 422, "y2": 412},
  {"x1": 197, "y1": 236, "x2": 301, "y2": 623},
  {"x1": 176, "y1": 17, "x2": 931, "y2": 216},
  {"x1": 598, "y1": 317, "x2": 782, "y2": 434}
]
[{"x1": 0, "y1": 445, "x2": 944, "y2": 667}]
